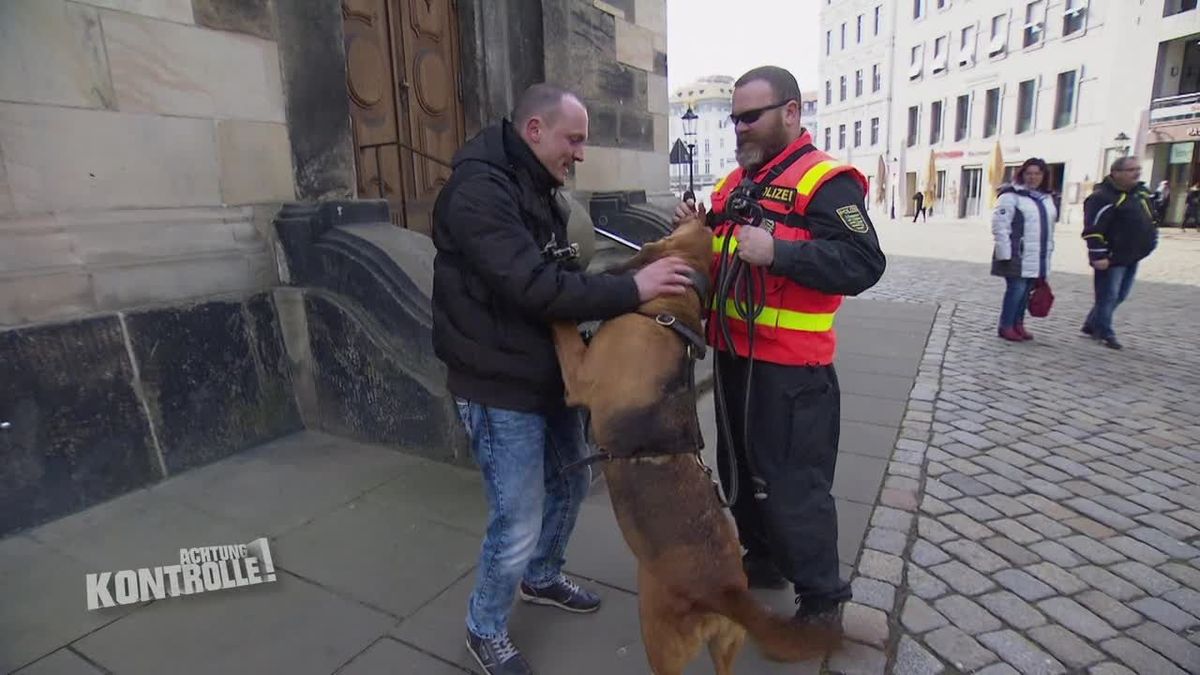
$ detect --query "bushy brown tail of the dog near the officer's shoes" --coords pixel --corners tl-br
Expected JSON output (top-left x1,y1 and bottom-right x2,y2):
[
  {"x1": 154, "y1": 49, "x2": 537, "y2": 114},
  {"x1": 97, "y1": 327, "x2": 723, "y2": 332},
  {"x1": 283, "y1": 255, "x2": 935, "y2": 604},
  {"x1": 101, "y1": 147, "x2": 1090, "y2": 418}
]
[{"x1": 720, "y1": 589, "x2": 841, "y2": 662}]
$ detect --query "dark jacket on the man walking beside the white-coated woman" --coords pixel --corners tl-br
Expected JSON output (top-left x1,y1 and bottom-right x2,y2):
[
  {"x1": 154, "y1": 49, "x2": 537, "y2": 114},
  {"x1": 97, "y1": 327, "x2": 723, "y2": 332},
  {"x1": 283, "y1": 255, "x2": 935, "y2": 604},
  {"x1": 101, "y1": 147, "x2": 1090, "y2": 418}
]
[{"x1": 1082, "y1": 177, "x2": 1158, "y2": 265}]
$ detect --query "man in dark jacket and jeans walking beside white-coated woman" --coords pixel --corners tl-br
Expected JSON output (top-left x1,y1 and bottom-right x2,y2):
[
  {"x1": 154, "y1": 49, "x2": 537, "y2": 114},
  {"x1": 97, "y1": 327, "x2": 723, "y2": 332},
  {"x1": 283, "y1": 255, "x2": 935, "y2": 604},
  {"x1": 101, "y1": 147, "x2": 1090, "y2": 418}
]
[{"x1": 1081, "y1": 157, "x2": 1158, "y2": 350}]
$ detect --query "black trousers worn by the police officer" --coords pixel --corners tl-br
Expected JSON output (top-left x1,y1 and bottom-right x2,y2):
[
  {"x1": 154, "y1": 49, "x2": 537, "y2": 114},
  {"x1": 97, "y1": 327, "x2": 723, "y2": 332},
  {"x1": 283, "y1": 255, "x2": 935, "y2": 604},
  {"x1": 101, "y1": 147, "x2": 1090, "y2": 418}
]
[{"x1": 716, "y1": 352, "x2": 851, "y2": 603}]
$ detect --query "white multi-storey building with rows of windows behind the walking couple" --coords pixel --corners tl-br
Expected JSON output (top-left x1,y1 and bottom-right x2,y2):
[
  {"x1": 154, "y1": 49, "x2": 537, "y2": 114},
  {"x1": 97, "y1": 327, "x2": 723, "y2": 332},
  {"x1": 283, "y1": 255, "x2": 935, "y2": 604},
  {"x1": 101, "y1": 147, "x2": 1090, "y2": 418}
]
[{"x1": 821, "y1": 0, "x2": 1200, "y2": 223}]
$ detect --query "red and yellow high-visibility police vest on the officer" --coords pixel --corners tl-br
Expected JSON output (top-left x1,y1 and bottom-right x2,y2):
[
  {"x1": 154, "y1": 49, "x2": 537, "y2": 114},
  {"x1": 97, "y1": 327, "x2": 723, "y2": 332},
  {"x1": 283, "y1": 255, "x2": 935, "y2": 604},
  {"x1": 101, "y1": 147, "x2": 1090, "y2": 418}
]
[{"x1": 708, "y1": 131, "x2": 866, "y2": 365}]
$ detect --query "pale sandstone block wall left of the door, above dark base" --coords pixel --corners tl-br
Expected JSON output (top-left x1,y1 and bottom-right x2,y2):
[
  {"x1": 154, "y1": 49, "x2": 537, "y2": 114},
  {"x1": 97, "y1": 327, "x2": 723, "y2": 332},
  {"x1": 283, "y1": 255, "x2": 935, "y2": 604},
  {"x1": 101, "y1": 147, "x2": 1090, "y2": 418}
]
[{"x1": 0, "y1": 0, "x2": 295, "y2": 325}]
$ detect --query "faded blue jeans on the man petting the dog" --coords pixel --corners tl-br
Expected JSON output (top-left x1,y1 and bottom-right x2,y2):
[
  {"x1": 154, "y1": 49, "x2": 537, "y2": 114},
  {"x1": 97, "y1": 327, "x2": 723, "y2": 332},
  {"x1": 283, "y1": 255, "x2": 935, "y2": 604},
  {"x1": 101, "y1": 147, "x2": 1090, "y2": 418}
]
[{"x1": 456, "y1": 399, "x2": 592, "y2": 638}]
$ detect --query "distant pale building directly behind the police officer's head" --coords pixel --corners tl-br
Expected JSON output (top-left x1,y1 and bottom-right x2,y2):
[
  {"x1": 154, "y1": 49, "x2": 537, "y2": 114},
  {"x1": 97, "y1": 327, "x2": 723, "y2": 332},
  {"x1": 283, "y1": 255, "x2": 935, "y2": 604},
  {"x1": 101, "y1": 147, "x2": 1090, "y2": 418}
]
[{"x1": 670, "y1": 76, "x2": 818, "y2": 203}]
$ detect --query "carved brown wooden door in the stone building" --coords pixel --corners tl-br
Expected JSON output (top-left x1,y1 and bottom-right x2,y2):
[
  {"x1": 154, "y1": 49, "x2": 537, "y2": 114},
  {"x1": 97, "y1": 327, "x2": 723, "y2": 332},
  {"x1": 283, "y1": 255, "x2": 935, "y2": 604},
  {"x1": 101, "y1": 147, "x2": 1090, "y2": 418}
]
[{"x1": 342, "y1": 0, "x2": 463, "y2": 234}]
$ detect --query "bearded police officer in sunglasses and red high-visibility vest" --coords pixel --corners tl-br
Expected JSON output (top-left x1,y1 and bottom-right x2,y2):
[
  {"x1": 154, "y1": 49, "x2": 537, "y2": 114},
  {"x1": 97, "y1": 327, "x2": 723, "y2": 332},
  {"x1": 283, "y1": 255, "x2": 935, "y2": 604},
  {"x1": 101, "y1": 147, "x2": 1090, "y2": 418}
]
[{"x1": 676, "y1": 66, "x2": 886, "y2": 625}]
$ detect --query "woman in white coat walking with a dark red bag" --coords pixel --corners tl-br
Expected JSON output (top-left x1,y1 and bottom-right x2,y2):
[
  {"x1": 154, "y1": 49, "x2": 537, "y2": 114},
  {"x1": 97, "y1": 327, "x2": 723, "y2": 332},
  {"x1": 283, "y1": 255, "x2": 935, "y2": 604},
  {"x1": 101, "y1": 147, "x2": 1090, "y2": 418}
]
[{"x1": 991, "y1": 157, "x2": 1058, "y2": 342}]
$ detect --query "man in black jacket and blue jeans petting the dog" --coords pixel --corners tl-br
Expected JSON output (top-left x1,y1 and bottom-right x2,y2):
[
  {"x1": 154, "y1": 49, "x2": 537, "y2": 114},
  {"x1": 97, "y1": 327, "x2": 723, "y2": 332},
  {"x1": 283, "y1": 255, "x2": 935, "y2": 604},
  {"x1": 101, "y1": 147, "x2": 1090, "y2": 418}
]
[{"x1": 433, "y1": 84, "x2": 690, "y2": 675}]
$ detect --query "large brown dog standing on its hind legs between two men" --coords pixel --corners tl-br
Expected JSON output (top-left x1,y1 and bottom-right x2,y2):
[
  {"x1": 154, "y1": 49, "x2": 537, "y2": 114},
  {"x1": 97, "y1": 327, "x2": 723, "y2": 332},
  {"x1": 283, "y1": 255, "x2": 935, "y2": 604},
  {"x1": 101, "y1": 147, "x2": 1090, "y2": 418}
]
[{"x1": 553, "y1": 209, "x2": 839, "y2": 675}]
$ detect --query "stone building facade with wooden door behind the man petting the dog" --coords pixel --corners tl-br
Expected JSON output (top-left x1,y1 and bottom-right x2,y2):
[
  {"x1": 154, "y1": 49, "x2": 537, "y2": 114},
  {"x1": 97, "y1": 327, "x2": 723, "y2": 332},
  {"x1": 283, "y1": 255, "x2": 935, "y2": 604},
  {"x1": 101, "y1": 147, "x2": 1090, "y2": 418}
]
[{"x1": 0, "y1": 0, "x2": 667, "y2": 533}]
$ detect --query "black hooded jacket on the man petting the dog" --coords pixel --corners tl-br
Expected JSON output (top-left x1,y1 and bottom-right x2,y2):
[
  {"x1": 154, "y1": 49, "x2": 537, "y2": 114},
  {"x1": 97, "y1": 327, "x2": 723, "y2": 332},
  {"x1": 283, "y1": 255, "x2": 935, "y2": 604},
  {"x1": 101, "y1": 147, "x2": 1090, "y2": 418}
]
[{"x1": 433, "y1": 121, "x2": 638, "y2": 412}]
